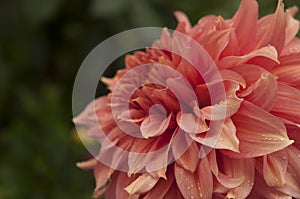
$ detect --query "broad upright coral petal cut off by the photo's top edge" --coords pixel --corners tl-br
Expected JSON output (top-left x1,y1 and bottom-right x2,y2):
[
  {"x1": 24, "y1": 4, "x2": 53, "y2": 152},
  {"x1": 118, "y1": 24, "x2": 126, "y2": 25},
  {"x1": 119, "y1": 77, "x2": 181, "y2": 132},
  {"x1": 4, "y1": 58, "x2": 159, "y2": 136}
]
[{"x1": 232, "y1": 0, "x2": 258, "y2": 54}]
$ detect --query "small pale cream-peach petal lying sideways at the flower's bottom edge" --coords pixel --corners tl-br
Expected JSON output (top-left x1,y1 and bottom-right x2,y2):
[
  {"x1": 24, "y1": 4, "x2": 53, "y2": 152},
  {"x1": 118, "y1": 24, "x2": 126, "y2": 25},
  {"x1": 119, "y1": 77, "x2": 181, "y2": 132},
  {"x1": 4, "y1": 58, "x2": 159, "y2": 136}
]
[{"x1": 125, "y1": 173, "x2": 159, "y2": 195}]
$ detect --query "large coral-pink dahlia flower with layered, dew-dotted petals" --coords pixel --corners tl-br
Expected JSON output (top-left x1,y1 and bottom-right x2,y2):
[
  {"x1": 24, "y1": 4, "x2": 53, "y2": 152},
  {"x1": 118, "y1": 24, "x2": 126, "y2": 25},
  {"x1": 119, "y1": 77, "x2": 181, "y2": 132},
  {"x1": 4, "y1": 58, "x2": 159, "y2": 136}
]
[{"x1": 74, "y1": 0, "x2": 300, "y2": 199}]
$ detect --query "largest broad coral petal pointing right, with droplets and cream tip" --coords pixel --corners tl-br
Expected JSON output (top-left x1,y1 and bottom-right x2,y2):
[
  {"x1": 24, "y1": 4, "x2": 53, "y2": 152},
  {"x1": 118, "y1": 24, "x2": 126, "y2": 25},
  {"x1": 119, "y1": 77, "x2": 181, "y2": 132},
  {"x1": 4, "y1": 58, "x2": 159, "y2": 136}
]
[{"x1": 223, "y1": 101, "x2": 293, "y2": 158}]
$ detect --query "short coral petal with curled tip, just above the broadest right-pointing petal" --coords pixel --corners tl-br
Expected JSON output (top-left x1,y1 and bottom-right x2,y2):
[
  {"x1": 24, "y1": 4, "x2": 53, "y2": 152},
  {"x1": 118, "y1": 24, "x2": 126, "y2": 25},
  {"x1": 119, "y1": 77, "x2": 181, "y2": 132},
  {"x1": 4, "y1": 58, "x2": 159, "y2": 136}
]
[{"x1": 239, "y1": 73, "x2": 277, "y2": 111}]
